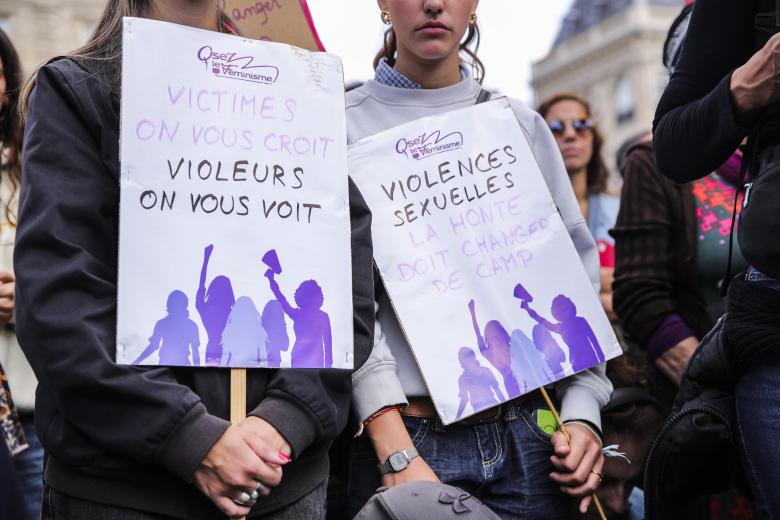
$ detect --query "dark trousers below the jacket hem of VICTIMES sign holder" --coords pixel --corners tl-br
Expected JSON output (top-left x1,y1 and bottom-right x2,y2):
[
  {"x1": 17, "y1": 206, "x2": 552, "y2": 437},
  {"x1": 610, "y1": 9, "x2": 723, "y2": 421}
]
[{"x1": 41, "y1": 481, "x2": 328, "y2": 520}]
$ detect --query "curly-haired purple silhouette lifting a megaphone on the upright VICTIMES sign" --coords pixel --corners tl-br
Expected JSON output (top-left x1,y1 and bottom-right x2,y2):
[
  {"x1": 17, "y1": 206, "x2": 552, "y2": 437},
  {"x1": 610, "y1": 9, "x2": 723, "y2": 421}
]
[{"x1": 265, "y1": 251, "x2": 333, "y2": 368}]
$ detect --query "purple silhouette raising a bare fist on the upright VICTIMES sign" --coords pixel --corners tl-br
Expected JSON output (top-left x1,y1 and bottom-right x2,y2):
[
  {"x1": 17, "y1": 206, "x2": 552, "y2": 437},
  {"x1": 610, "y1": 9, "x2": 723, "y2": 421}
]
[{"x1": 195, "y1": 245, "x2": 236, "y2": 366}]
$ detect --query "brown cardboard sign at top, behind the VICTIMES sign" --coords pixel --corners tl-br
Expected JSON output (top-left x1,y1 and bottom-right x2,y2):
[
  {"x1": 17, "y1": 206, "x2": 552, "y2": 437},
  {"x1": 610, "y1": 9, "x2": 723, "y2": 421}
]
[{"x1": 217, "y1": 0, "x2": 325, "y2": 51}]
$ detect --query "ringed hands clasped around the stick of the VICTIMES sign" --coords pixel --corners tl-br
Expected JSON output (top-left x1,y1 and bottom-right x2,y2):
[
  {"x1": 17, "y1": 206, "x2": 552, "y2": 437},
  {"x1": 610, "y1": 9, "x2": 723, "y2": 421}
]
[{"x1": 194, "y1": 426, "x2": 288, "y2": 518}]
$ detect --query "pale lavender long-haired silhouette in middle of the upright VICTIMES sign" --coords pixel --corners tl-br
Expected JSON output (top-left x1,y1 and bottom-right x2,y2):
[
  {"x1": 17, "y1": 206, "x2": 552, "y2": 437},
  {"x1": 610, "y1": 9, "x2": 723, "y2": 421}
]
[{"x1": 221, "y1": 296, "x2": 268, "y2": 367}]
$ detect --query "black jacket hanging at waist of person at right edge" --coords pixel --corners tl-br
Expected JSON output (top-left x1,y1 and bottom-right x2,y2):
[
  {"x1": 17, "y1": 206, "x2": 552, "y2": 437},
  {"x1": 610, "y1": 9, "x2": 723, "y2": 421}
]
[{"x1": 644, "y1": 270, "x2": 780, "y2": 520}]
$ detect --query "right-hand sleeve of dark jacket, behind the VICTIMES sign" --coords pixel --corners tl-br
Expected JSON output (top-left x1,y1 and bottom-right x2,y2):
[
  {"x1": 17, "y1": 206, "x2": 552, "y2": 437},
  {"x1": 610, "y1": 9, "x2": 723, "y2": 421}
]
[{"x1": 251, "y1": 179, "x2": 374, "y2": 457}]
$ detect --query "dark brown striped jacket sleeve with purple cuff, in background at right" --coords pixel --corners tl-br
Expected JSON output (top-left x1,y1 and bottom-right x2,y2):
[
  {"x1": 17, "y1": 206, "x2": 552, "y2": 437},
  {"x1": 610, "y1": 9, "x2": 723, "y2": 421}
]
[{"x1": 610, "y1": 143, "x2": 714, "y2": 349}]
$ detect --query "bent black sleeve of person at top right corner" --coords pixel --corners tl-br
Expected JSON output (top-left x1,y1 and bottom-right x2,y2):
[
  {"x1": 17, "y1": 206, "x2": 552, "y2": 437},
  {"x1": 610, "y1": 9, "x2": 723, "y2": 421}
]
[{"x1": 653, "y1": 0, "x2": 760, "y2": 182}]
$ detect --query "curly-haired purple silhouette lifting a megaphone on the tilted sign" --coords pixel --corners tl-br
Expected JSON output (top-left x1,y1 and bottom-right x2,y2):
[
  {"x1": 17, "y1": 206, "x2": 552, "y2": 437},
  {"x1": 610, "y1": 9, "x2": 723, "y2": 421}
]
[{"x1": 520, "y1": 294, "x2": 604, "y2": 373}]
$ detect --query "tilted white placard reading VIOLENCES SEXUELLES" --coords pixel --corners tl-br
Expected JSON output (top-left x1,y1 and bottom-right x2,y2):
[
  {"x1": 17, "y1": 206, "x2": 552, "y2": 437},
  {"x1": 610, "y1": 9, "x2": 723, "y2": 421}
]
[{"x1": 349, "y1": 98, "x2": 621, "y2": 424}]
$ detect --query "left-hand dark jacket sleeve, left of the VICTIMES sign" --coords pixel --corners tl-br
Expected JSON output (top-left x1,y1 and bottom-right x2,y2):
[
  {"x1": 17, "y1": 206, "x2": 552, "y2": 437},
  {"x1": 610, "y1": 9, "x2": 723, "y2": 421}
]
[{"x1": 14, "y1": 60, "x2": 228, "y2": 481}]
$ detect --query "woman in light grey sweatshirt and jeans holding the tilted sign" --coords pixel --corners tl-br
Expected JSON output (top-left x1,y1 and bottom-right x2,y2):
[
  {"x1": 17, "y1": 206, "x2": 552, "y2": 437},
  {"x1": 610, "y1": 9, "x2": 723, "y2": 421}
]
[{"x1": 347, "y1": 0, "x2": 611, "y2": 519}]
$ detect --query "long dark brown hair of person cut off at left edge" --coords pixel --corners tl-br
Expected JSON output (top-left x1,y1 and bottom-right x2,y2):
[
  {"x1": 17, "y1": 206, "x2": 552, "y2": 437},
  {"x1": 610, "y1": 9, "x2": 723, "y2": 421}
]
[{"x1": 0, "y1": 29, "x2": 22, "y2": 223}]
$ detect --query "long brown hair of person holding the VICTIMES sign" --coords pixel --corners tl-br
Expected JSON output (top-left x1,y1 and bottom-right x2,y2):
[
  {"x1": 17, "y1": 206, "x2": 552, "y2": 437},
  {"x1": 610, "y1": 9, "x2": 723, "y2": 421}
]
[{"x1": 19, "y1": 0, "x2": 236, "y2": 123}]
